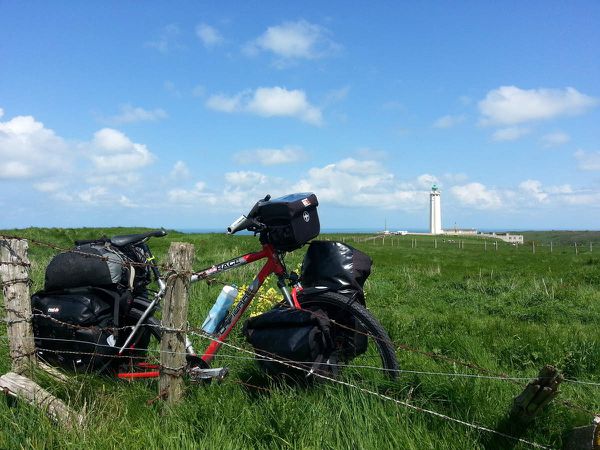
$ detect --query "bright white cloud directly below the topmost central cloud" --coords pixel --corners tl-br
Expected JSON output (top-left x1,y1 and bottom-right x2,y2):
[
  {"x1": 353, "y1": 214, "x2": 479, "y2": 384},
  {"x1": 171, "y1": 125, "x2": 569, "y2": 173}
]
[{"x1": 206, "y1": 86, "x2": 323, "y2": 125}]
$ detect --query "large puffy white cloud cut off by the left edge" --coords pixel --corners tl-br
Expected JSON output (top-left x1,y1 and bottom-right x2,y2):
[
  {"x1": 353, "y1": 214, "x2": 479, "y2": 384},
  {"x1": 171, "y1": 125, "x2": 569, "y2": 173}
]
[{"x1": 0, "y1": 112, "x2": 73, "y2": 179}]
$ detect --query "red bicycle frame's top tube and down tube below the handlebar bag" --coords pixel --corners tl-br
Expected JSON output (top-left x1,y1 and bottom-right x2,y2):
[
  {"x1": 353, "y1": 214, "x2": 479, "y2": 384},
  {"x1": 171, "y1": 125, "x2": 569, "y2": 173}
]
[{"x1": 190, "y1": 244, "x2": 300, "y2": 363}]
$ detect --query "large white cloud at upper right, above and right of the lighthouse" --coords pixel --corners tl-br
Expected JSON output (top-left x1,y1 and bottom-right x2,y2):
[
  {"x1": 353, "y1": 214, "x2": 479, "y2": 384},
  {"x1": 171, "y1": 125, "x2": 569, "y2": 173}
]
[{"x1": 479, "y1": 86, "x2": 598, "y2": 125}]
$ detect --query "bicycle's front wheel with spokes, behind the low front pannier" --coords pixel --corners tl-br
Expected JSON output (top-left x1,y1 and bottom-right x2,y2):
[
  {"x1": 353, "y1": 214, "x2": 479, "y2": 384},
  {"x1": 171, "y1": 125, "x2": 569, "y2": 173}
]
[{"x1": 298, "y1": 292, "x2": 398, "y2": 381}]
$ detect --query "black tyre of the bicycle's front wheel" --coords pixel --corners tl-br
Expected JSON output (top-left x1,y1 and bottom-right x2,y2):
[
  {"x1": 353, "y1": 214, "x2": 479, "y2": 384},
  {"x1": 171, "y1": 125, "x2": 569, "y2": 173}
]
[{"x1": 298, "y1": 292, "x2": 398, "y2": 380}]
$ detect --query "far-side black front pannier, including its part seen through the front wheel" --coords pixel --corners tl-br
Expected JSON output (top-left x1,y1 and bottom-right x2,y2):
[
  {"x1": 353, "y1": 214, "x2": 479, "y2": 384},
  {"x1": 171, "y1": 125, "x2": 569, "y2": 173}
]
[{"x1": 299, "y1": 241, "x2": 373, "y2": 358}]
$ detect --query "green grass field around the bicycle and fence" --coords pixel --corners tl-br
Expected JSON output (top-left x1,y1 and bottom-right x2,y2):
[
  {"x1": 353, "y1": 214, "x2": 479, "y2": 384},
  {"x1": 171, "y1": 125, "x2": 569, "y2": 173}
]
[{"x1": 0, "y1": 229, "x2": 600, "y2": 449}]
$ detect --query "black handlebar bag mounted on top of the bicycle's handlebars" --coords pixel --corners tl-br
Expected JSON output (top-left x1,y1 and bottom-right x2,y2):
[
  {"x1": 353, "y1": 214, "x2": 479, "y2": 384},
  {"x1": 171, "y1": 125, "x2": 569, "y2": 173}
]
[{"x1": 255, "y1": 192, "x2": 321, "y2": 251}]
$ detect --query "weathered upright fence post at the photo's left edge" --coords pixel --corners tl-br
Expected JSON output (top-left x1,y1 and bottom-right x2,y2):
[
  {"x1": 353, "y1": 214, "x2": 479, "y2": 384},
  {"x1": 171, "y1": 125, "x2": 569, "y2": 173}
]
[{"x1": 0, "y1": 239, "x2": 36, "y2": 374}]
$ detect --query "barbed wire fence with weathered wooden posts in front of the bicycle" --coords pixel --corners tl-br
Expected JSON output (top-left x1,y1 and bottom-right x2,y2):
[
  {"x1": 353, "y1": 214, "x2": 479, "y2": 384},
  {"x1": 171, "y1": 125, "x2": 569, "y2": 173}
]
[{"x1": 0, "y1": 235, "x2": 600, "y2": 448}]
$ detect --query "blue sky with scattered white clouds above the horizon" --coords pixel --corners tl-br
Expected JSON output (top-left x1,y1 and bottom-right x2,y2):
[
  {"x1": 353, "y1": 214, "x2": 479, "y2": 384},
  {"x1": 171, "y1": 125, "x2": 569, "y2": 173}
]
[{"x1": 0, "y1": 0, "x2": 600, "y2": 229}]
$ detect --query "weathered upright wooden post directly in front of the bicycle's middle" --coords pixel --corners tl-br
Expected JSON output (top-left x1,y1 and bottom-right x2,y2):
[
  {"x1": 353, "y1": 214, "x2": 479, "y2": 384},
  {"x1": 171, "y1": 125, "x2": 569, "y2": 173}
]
[{"x1": 158, "y1": 242, "x2": 194, "y2": 403}]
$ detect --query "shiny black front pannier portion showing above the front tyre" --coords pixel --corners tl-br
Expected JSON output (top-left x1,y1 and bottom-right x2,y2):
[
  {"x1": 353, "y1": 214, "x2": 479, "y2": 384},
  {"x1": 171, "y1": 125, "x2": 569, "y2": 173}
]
[{"x1": 300, "y1": 241, "x2": 373, "y2": 305}]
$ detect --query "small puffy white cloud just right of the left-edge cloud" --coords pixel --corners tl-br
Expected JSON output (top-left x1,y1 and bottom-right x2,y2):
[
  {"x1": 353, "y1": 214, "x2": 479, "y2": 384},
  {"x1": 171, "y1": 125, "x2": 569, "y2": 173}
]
[{"x1": 91, "y1": 128, "x2": 155, "y2": 172}]
